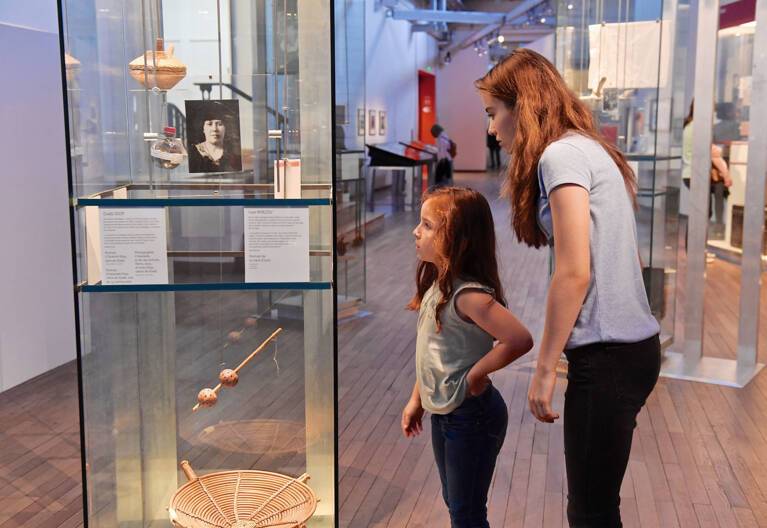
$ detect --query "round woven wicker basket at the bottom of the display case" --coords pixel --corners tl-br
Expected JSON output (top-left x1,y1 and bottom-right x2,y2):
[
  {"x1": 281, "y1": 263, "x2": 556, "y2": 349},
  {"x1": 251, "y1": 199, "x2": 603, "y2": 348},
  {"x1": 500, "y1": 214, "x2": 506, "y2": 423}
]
[{"x1": 168, "y1": 461, "x2": 317, "y2": 528}]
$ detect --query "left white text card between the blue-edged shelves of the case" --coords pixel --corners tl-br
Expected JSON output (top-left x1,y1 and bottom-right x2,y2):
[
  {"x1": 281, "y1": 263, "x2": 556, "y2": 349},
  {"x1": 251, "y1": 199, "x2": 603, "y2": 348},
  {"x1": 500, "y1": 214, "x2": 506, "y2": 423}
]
[{"x1": 101, "y1": 207, "x2": 168, "y2": 285}]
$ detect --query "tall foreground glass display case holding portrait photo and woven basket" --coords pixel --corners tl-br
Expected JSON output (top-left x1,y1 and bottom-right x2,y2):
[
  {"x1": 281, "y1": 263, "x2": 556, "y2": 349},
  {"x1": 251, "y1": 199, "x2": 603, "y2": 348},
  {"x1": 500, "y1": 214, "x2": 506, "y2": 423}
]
[{"x1": 60, "y1": 0, "x2": 337, "y2": 528}]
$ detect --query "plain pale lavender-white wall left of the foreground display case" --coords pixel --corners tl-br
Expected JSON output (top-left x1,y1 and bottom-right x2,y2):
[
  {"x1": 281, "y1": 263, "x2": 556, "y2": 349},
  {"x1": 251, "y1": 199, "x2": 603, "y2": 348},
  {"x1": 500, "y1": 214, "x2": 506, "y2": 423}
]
[{"x1": 0, "y1": 10, "x2": 75, "y2": 391}]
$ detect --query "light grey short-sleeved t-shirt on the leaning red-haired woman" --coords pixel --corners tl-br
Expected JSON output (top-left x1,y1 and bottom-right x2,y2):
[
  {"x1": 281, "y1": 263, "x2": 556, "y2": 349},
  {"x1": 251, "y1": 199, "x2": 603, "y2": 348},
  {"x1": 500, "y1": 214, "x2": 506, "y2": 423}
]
[{"x1": 538, "y1": 133, "x2": 660, "y2": 349}]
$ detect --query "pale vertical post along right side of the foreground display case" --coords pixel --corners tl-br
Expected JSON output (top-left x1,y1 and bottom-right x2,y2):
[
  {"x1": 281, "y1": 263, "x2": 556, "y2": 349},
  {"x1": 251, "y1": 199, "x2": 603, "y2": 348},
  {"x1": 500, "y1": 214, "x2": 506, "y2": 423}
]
[{"x1": 300, "y1": 0, "x2": 337, "y2": 528}]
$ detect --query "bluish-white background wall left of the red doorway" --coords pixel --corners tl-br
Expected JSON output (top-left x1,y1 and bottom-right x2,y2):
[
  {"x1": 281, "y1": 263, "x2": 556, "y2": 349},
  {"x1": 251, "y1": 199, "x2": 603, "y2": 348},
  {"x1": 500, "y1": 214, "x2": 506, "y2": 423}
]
[{"x1": 366, "y1": 0, "x2": 438, "y2": 143}]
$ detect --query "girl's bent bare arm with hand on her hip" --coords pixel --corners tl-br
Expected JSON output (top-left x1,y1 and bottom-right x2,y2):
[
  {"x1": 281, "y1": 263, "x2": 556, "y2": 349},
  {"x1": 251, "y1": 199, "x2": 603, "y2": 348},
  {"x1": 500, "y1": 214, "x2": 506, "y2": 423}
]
[{"x1": 455, "y1": 290, "x2": 533, "y2": 395}]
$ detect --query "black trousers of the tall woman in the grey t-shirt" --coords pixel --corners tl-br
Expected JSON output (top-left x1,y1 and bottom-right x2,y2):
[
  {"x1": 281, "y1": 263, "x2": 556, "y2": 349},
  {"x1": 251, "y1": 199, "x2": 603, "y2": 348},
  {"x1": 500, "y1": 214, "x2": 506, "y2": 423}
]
[{"x1": 564, "y1": 335, "x2": 660, "y2": 528}]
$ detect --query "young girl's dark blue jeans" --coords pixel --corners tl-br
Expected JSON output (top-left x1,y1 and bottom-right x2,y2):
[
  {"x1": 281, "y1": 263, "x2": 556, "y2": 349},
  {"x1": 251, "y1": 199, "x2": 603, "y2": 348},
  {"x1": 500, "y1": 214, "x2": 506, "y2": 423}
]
[{"x1": 431, "y1": 385, "x2": 509, "y2": 528}]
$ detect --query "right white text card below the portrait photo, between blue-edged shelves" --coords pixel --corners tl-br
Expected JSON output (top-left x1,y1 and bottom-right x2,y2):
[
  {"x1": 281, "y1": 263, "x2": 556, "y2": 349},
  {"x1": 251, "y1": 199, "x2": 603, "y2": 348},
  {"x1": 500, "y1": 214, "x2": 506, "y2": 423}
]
[{"x1": 245, "y1": 207, "x2": 309, "y2": 282}]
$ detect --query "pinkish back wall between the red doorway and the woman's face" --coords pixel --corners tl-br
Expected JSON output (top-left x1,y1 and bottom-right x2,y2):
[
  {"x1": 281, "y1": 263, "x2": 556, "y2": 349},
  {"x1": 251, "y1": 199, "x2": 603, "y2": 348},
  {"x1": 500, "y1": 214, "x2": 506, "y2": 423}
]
[{"x1": 437, "y1": 40, "x2": 489, "y2": 171}]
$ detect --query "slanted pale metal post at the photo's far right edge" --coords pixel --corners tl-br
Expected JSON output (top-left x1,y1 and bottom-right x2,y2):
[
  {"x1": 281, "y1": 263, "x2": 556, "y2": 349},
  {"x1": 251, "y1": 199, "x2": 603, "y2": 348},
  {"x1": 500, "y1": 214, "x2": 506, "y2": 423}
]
[{"x1": 738, "y1": 0, "x2": 767, "y2": 374}]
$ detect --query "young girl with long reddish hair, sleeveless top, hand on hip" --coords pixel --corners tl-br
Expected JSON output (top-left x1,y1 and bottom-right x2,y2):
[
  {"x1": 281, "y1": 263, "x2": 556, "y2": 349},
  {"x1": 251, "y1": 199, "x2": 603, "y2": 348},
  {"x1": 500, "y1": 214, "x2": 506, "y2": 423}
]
[{"x1": 402, "y1": 187, "x2": 533, "y2": 528}]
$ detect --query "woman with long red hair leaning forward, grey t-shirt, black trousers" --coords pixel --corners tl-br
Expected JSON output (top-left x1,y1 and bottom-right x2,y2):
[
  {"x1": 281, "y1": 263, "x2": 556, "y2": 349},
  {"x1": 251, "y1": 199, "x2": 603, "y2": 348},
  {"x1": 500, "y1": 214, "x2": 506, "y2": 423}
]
[{"x1": 475, "y1": 49, "x2": 660, "y2": 528}]
